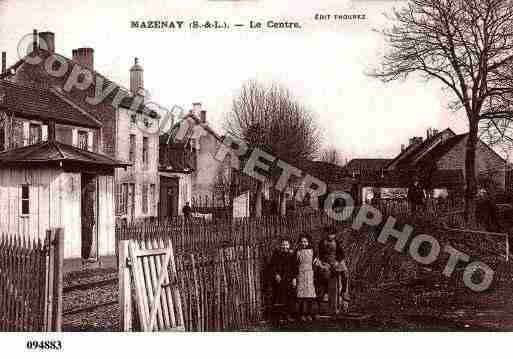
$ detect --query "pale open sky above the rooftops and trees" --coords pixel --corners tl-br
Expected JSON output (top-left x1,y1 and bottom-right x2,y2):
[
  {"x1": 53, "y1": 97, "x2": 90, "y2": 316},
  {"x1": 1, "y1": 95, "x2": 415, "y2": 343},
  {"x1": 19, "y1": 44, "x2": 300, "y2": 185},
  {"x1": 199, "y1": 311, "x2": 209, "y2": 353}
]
[{"x1": 0, "y1": 0, "x2": 480, "y2": 159}]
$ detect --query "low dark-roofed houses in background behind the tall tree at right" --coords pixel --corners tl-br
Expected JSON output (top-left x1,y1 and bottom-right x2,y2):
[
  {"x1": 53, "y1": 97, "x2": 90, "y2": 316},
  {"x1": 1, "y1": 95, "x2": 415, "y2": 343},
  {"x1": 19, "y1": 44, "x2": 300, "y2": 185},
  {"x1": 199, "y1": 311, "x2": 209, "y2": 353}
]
[{"x1": 345, "y1": 128, "x2": 506, "y2": 202}]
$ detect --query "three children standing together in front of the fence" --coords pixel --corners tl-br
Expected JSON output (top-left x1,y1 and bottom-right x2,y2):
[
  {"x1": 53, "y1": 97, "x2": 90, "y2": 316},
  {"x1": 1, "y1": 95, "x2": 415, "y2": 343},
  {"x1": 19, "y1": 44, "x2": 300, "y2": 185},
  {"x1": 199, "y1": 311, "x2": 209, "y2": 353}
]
[{"x1": 269, "y1": 227, "x2": 349, "y2": 322}]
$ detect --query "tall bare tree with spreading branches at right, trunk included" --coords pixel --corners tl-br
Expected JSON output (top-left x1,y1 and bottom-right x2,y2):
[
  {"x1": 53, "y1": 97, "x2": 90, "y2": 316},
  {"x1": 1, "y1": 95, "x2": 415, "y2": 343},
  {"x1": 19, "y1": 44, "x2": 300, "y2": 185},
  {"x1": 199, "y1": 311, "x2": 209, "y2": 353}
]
[{"x1": 372, "y1": 0, "x2": 513, "y2": 220}]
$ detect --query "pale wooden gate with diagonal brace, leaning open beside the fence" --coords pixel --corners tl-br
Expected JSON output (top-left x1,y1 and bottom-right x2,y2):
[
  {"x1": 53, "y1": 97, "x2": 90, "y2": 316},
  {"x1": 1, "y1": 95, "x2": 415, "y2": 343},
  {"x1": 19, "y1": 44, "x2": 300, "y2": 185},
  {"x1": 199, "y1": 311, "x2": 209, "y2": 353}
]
[{"x1": 124, "y1": 241, "x2": 185, "y2": 332}]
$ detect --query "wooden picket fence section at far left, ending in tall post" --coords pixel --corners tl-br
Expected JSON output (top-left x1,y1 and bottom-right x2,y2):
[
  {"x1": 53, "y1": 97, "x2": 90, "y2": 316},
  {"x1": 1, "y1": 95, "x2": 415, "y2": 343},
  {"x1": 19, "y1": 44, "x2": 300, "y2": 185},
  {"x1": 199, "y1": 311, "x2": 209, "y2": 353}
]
[{"x1": 0, "y1": 228, "x2": 64, "y2": 331}]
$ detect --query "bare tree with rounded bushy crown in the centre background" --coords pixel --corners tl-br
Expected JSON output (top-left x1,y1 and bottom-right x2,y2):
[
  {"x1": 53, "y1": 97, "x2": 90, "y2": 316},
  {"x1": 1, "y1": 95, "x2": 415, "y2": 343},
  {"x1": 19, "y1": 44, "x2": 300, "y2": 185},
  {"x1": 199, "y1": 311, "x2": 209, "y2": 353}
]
[{"x1": 225, "y1": 80, "x2": 320, "y2": 216}]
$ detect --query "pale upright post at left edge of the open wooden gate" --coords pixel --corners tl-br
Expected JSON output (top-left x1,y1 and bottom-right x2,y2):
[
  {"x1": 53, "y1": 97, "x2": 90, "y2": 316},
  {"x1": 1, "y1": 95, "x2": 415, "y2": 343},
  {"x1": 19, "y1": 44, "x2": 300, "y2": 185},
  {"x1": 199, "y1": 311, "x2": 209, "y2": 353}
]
[{"x1": 116, "y1": 236, "x2": 132, "y2": 332}]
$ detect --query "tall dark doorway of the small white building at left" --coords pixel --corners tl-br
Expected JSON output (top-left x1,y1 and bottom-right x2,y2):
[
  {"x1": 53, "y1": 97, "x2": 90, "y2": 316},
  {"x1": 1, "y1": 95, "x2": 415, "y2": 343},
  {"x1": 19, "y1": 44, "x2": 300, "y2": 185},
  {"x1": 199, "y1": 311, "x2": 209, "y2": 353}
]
[{"x1": 81, "y1": 173, "x2": 98, "y2": 262}]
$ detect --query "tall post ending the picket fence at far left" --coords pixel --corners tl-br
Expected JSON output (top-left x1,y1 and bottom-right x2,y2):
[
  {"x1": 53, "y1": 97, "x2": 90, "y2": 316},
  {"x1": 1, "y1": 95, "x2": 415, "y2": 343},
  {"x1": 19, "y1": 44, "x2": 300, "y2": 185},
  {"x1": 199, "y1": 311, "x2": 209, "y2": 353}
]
[{"x1": 52, "y1": 228, "x2": 64, "y2": 332}]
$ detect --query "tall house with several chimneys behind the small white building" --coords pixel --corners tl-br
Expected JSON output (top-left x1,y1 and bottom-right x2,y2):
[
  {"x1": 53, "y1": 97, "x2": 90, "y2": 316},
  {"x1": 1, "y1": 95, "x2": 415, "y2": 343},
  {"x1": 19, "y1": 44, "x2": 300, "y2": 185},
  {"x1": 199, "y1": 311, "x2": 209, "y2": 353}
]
[{"x1": 1, "y1": 31, "x2": 159, "y2": 225}]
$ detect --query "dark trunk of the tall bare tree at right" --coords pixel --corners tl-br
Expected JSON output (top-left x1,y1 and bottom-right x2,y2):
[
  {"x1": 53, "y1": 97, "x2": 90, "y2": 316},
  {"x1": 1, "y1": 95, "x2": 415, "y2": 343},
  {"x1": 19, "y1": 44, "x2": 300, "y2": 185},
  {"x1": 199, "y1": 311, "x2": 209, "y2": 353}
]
[{"x1": 465, "y1": 120, "x2": 478, "y2": 224}]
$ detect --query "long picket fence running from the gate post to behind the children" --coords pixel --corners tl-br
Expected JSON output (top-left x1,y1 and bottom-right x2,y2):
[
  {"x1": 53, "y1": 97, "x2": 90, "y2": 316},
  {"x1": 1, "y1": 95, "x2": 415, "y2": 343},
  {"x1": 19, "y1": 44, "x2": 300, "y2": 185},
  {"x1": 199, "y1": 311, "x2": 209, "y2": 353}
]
[{"x1": 116, "y1": 212, "x2": 333, "y2": 331}]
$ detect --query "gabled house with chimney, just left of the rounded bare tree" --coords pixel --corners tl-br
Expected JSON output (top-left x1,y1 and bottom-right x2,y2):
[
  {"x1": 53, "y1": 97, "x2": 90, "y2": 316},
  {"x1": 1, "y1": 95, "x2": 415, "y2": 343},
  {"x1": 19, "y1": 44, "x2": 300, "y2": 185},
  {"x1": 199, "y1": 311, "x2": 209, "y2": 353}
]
[{"x1": 159, "y1": 103, "x2": 242, "y2": 218}]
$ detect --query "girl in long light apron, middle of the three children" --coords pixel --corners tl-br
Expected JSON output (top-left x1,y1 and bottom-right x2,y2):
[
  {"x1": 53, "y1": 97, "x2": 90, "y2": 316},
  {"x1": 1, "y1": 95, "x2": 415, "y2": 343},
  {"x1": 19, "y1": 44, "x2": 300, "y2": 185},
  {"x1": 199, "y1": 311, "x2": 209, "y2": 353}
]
[{"x1": 295, "y1": 234, "x2": 316, "y2": 321}]
